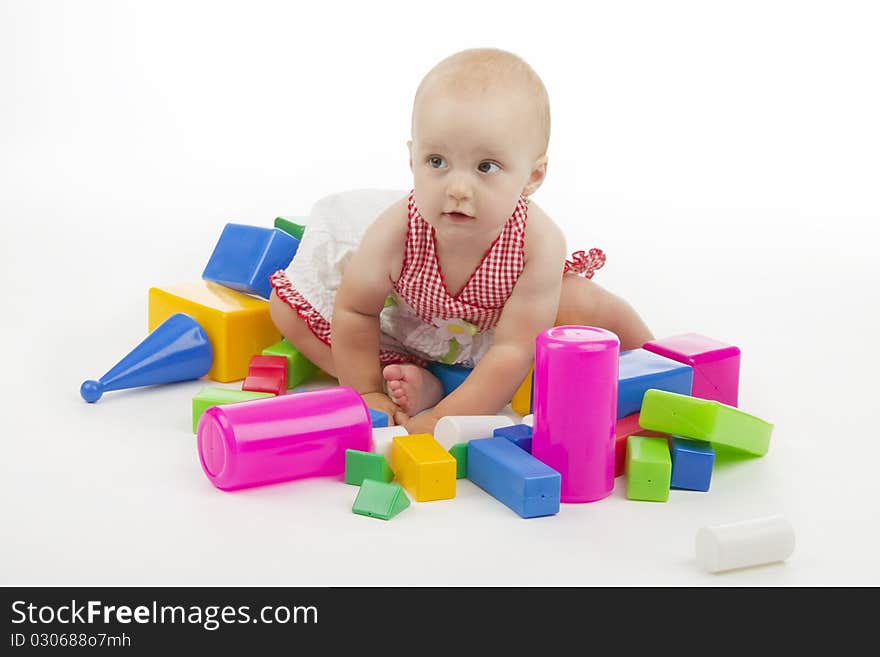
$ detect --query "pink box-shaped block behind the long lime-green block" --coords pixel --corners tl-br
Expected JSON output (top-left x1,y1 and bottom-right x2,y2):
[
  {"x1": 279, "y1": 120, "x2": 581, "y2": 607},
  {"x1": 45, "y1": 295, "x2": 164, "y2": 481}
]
[{"x1": 643, "y1": 333, "x2": 740, "y2": 406}]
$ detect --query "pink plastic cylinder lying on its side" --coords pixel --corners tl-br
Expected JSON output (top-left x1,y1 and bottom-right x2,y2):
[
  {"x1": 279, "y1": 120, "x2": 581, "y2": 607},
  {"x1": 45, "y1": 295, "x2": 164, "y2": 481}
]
[{"x1": 198, "y1": 386, "x2": 373, "y2": 490}]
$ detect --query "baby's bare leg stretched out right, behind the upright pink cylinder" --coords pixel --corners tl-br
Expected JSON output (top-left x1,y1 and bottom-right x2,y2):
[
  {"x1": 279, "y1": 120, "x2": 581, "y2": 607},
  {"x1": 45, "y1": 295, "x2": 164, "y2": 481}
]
[{"x1": 556, "y1": 274, "x2": 654, "y2": 351}]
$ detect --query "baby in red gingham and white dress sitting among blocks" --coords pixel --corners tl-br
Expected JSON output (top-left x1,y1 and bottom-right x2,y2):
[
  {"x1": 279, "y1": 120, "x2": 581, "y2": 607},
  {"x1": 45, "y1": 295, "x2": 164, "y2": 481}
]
[{"x1": 269, "y1": 49, "x2": 653, "y2": 433}]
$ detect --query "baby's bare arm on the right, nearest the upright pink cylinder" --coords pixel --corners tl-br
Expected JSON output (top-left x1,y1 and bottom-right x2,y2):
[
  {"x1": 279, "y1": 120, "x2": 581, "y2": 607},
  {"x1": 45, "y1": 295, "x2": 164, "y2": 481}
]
[{"x1": 407, "y1": 212, "x2": 566, "y2": 431}]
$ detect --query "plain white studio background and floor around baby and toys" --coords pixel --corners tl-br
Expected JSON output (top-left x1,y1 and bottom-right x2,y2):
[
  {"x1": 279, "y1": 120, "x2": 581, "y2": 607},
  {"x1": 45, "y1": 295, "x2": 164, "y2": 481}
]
[{"x1": 0, "y1": 0, "x2": 880, "y2": 586}]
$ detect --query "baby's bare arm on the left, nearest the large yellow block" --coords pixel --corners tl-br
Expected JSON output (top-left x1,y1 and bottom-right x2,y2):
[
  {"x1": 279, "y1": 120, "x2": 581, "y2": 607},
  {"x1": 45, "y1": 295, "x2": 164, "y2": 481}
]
[{"x1": 330, "y1": 199, "x2": 407, "y2": 418}]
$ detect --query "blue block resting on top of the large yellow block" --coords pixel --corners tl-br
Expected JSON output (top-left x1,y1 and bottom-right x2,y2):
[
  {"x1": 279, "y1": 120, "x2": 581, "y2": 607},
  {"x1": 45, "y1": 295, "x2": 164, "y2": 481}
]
[{"x1": 202, "y1": 224, "x2": 299, "y2": 299}]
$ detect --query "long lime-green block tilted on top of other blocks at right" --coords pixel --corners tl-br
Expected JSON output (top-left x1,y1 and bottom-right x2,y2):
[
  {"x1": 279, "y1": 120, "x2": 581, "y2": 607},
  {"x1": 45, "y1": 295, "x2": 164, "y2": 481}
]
[{"x1": 639, "y1": 390, "x2": 773, "y2": 456}]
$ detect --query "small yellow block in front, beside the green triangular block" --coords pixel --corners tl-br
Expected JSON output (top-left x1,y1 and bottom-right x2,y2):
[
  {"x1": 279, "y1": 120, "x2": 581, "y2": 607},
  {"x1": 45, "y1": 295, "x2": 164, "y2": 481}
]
[{"x1": 391, "y1": 433, "x2": 455, "y2": 502}]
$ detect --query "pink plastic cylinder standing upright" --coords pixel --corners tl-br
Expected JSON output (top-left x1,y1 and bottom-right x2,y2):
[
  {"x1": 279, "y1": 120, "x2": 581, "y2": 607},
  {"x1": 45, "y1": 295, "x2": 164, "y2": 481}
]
[{"x1": 532, "y1": 326, "x2": 620, "y2": 502}]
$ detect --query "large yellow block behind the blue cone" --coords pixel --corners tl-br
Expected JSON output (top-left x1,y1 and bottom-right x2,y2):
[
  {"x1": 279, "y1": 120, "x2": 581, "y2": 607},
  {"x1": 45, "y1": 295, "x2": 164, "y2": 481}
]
[{"x1": 149, "y1": 281, "x2": 281, "y2": 383}]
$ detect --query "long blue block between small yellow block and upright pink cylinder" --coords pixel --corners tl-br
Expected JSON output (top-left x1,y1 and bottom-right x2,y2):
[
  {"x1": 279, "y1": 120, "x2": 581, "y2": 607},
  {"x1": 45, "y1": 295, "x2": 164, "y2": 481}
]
[{"x1": 468, "y1": 436, "x2": 562, "y2": 518}]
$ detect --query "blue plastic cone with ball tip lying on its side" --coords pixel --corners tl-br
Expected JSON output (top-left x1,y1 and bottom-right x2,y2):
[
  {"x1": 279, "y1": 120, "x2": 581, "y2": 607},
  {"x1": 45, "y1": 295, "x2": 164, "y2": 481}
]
[{"x1": 79, "y1": 313, "x2": 214, "y2": 403}]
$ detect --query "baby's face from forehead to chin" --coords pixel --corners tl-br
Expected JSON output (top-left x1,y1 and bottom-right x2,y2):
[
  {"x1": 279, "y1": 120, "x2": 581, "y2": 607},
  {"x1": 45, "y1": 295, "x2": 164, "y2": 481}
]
[{"x1": 409, "y1": 91, "x2": 543, "y2": 239}]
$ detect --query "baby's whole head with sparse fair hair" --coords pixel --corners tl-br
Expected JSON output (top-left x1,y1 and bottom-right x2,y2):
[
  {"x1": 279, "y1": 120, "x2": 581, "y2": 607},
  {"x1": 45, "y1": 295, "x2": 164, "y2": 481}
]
[{"x1": 408, "y1": 48, "x2": 550, "y2": 235}]
